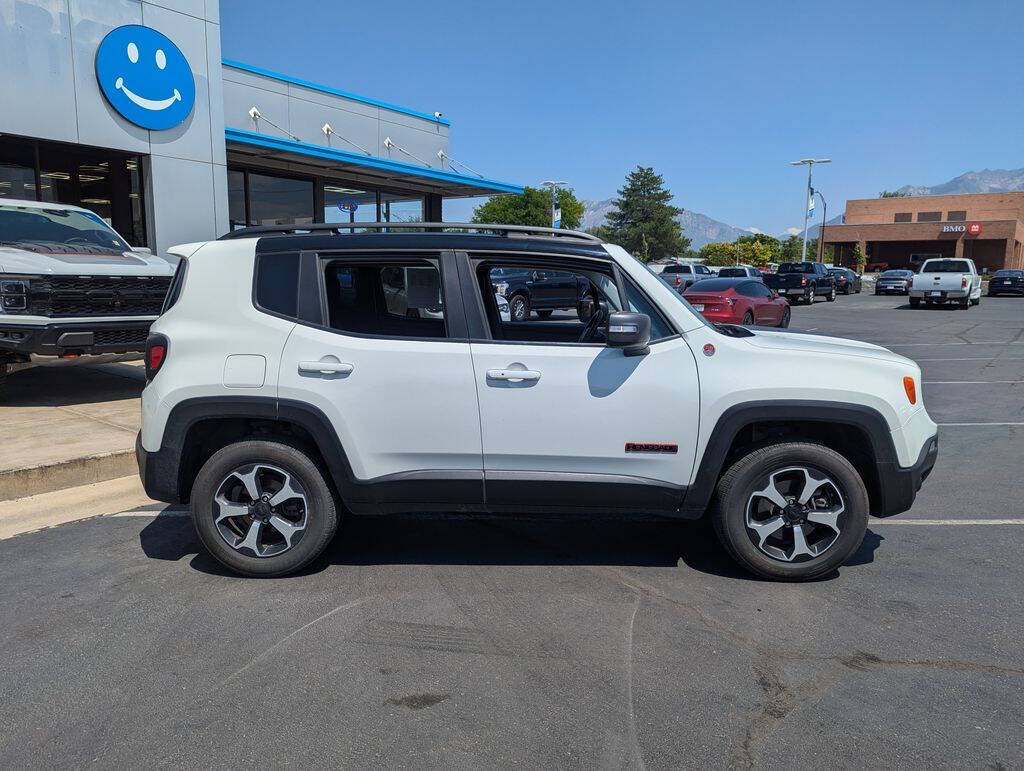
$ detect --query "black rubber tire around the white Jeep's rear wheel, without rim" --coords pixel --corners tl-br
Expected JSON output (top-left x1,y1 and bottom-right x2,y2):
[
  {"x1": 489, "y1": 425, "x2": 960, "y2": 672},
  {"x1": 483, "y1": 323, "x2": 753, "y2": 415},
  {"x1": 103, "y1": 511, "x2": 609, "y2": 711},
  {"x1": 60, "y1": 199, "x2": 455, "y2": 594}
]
[{"x1": 190, "y1": 440, "x2": 338, "y2": 577}]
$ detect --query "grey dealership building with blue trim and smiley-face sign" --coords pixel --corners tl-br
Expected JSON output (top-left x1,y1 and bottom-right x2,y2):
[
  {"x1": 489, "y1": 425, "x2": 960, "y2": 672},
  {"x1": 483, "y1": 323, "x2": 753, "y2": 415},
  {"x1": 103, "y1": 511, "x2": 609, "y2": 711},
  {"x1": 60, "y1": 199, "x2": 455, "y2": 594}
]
[{"x1": 0, "y1": 0, "x2": 522, "y2": 253}]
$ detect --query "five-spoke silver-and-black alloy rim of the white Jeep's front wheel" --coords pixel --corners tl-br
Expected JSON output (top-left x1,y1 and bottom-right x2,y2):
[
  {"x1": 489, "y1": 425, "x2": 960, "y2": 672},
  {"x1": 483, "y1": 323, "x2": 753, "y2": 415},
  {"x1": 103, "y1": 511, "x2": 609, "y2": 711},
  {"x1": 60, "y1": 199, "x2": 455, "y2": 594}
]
[{"x1": 744, "y1": 466, "x2": 846, "y2": 562}]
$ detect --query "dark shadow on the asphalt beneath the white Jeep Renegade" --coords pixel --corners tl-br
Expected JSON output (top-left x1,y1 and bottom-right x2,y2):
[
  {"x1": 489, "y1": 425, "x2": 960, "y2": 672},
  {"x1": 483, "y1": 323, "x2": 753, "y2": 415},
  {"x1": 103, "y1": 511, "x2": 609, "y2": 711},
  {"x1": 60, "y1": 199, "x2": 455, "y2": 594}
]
[{"x1": 139, "y1": 516, "x2": 883, "y2": 581}]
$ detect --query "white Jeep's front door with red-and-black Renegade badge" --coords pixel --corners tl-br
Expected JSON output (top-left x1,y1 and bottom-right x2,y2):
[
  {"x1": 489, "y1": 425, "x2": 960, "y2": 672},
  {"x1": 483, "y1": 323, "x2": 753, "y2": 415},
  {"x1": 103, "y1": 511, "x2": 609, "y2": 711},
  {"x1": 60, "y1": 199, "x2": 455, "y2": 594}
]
[{"x1": 466, "y1": 252, "x2": 699, "y2": 509}]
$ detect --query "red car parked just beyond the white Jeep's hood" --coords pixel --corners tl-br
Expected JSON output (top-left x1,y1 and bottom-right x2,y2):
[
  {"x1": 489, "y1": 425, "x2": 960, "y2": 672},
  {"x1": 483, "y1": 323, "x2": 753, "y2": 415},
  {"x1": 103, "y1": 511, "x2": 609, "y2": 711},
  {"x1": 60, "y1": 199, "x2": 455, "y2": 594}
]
[{"x1": 683, "y1": 279, "x2": 791, "y2": 327}]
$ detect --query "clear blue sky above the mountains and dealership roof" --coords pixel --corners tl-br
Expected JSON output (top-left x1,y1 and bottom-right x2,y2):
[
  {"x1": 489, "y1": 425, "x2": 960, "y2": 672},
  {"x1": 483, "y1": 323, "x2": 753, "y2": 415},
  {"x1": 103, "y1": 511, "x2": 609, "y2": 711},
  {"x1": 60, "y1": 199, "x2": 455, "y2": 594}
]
[{"x1": 221, "y1": 0, "x2": 1024, "y2": 234}]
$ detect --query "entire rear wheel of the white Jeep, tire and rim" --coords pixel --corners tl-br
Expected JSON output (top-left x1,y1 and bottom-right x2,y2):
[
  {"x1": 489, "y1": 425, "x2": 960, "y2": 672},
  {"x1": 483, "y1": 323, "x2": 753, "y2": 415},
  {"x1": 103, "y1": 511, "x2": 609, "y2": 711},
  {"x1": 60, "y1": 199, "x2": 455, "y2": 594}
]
[{"x1": 191, "y1": 440, "x2": 338, "y2": 577}]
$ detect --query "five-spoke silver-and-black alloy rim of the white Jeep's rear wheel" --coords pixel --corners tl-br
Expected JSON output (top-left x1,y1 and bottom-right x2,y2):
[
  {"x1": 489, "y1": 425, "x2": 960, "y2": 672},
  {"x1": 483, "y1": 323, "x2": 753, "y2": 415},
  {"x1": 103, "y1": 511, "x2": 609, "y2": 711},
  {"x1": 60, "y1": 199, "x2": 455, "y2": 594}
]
[{"x1": 213, "y1": 463, "x2": 309, "y2": 557}]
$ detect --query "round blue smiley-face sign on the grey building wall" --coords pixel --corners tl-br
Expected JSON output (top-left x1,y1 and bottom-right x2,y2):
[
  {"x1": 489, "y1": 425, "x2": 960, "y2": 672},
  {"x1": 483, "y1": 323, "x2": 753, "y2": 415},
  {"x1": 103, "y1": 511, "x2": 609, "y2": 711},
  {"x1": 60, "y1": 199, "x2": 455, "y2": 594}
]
[{"x1": 96, "y1": 25, "x2": 196, "y2": 131}]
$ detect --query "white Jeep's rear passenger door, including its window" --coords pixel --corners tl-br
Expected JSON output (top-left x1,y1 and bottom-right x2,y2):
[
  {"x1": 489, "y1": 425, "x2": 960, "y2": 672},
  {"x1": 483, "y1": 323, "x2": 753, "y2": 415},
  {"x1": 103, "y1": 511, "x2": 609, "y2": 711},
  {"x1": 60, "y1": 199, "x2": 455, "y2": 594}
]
[{"x1": 279, "y1": 253, "x2": 483, "y2": 503}]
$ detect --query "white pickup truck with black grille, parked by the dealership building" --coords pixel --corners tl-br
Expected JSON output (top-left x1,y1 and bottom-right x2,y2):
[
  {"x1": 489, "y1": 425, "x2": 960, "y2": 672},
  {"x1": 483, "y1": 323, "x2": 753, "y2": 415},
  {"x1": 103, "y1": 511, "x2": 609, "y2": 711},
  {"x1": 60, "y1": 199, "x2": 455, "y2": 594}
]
[{"x1": 0, "y1": 199, "x2": 174, "y2": 392}]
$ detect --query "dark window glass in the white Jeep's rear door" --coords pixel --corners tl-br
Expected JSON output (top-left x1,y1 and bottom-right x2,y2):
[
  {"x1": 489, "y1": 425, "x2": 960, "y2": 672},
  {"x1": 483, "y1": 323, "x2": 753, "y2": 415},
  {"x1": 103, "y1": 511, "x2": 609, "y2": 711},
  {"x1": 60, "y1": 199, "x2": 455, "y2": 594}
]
[{"x1": 325, "y1": 260, "x2": 446, "y2": 338}]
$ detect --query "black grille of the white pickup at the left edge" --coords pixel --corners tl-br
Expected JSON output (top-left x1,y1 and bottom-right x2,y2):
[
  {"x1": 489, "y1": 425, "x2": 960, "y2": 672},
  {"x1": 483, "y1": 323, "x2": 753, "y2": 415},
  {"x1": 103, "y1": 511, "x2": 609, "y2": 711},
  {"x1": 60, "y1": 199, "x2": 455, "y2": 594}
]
[{"x1": 25, "y1": 275, "x2": 171, "y2": 318}]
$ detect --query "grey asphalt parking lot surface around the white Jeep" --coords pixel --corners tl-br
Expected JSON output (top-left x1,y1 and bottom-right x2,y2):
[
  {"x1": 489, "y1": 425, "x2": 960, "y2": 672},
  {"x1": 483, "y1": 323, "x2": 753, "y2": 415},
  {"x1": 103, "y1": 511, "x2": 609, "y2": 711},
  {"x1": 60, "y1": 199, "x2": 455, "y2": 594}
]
[{"x1": 0, "y1": 286, "x2": 1024, "y2": 768}]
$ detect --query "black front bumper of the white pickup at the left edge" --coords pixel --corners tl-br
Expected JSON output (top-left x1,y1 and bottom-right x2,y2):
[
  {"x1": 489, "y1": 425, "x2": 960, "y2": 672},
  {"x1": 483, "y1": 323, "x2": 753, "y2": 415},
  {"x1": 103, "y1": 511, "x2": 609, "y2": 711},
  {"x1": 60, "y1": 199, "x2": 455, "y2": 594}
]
[{"x1": 0, "y1": 316, "x2": 154, "y2": 360}]
